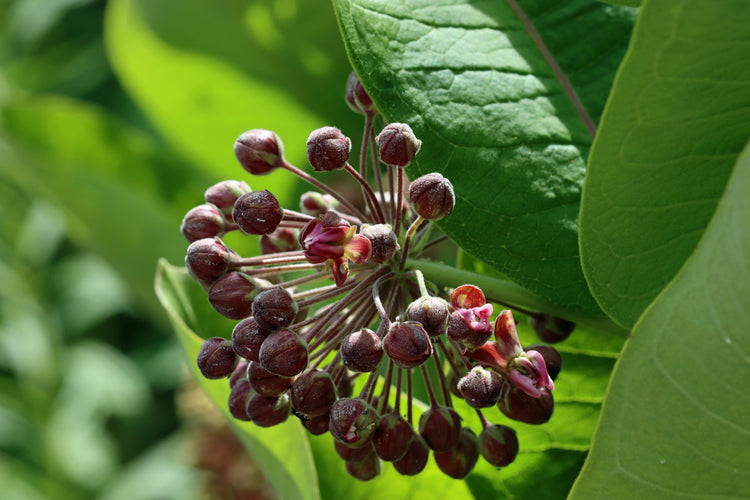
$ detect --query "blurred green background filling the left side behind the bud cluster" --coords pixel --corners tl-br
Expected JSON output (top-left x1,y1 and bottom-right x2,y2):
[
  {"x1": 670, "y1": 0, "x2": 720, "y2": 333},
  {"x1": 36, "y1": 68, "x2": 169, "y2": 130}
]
[{"x1": 0, "y1": 0, "x2": 361, "y2": 500}]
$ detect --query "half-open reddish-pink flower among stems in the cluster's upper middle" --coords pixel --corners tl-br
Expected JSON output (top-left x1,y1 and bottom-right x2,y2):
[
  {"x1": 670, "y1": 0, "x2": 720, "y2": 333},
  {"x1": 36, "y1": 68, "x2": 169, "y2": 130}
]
[{"x1": 299, "y1": 211, "x2": 372, "y2": 286}]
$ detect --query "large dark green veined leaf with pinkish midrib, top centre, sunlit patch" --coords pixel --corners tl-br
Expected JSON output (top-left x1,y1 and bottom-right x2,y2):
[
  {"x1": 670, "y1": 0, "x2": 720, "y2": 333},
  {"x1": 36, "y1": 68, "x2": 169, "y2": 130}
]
[{"x1": 334, "y1": 0, "x2": 633, "y2": 314}]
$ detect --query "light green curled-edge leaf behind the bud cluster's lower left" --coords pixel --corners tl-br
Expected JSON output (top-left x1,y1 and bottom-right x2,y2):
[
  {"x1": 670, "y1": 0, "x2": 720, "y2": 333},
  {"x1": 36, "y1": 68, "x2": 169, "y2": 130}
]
[{"x1": 155, "y1": 260, "x2": 320, "y2": 500}]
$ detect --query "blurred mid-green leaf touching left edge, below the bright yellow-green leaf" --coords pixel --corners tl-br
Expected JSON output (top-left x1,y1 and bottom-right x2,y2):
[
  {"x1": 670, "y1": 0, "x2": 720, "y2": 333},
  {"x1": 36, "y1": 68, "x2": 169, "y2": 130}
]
[{"x1": 0, "y1": 96, "x2": 209, "y2": 318}]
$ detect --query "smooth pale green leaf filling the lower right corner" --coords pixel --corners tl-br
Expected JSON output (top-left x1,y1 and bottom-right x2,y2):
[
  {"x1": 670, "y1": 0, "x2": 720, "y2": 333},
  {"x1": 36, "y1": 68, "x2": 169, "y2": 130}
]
[{"x1": 571, "y1": 143, "x2": 750, "y2": 499}]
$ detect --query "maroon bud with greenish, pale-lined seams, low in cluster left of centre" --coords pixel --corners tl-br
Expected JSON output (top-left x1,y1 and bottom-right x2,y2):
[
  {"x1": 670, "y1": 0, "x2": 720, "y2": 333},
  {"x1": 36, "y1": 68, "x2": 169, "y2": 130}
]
[{"x1": 329, "y1": 399, "x2": 378, "y2": 448}]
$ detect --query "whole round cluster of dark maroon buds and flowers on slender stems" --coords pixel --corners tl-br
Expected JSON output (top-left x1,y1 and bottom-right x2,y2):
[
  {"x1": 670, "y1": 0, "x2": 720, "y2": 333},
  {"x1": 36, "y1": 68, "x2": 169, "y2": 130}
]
[{"x1": 181, "y1": 74, "x2": 572, "y2": 480}]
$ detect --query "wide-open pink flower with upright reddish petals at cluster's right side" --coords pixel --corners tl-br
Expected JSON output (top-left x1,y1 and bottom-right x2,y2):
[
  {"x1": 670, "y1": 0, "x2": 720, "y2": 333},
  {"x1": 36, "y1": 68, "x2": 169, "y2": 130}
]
[{"x1": 466, "y1": 310, "x2": 555, "y2": 398}]
